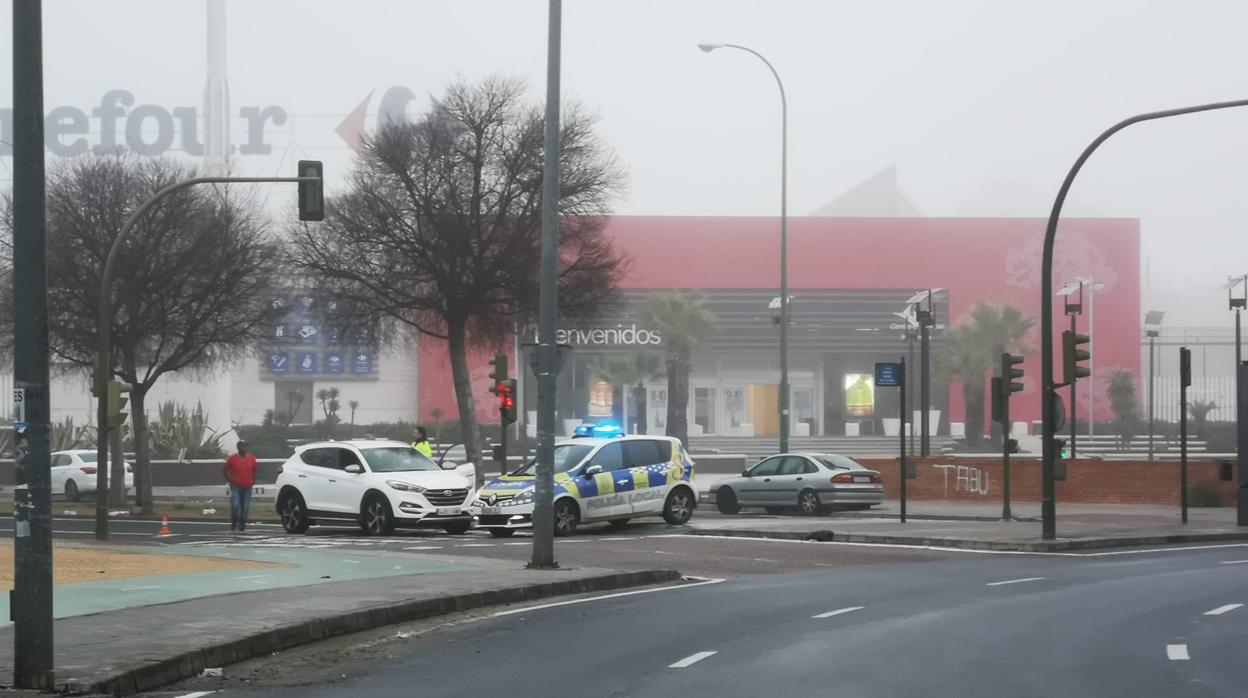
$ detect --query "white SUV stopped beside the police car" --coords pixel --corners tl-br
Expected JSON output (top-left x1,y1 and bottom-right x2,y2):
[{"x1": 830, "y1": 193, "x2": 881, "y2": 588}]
[{"x1": 277, "y1": 441, "x2": 475, "y2": 536}]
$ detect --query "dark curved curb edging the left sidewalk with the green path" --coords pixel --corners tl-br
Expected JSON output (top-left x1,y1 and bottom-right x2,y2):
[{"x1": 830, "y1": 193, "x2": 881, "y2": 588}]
[{"x1": 85, "y1": 569, "x2": 681, "y2": 696}]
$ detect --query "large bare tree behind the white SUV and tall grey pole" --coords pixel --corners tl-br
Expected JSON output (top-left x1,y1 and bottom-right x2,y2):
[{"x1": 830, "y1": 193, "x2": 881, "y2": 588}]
[{"x1": 291, "y1": 77, "x2": 624, "y2": 472}]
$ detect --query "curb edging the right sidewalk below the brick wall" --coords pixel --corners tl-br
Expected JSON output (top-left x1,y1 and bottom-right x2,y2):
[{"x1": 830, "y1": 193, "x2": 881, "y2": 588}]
[{"x1": 691, "y1": 529, "x2": 1248, "y2": 553}]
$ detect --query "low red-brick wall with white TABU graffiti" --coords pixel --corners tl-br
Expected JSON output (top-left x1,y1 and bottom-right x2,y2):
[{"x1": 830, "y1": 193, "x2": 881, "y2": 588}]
[{"x1": 859, "y1": 457, "x2": 1237, "y2": 506}]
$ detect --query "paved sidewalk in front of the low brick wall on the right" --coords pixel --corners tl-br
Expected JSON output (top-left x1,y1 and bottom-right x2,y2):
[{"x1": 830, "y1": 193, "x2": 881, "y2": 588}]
[{"x1": 689, "y1": 502, "x2": 1248, "y2": 552}]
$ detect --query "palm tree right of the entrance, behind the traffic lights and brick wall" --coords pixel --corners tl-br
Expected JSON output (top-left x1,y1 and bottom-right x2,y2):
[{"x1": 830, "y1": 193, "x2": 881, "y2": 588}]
[{"x1": 936, "y1": 302, "x2": 1036, "y2": 446}]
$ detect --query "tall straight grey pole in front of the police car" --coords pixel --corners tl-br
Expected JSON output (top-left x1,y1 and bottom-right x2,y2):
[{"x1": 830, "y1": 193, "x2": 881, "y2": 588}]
[{"x1": 529, "y1": 0, "x2": 563, "y2": 569}]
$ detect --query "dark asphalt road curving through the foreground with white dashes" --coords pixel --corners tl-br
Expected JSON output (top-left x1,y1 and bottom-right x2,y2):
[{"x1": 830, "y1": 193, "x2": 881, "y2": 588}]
[{"x1": 162, "y1": 543, "x2": 1248, "y2": 698}]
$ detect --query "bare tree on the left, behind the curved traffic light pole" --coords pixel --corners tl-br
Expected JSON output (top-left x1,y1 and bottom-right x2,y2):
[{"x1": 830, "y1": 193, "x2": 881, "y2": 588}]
[{"x1": 0, "y1": 155, "x2": 280, "y2": 511}]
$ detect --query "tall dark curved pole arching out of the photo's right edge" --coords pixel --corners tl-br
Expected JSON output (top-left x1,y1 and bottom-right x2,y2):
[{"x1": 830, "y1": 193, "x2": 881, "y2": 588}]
[{"x1": 1040, "y1": 100, "x2": 1248, "y2": 541}]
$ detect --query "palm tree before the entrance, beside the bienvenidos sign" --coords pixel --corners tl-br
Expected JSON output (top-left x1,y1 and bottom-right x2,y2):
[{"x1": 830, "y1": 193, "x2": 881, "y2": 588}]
[{"x1": 638, "y1": 291, "x2": 719, "y2": 445}]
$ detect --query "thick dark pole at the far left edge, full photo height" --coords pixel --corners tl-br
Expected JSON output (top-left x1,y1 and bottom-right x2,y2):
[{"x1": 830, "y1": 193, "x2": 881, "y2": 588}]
[{"x1": 9, "y1": 0, "x2": 55, "y2": 689}]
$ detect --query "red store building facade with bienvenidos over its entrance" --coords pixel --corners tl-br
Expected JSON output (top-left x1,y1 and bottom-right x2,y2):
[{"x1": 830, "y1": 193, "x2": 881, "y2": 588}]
[{"x1": 419, "y1": 216, "x2": 1141, "y2": 436}]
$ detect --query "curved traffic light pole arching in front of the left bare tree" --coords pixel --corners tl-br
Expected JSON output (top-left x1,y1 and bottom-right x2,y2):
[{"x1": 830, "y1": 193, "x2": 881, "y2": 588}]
[{"x1": 94, "y1": 174, "x2": 321, "y2": 541}]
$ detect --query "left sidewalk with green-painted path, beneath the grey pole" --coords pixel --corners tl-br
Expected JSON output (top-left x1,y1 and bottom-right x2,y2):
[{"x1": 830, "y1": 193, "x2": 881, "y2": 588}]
[{"x1": 0, "y1": 547, "x2": 680, "y2": 696}]
